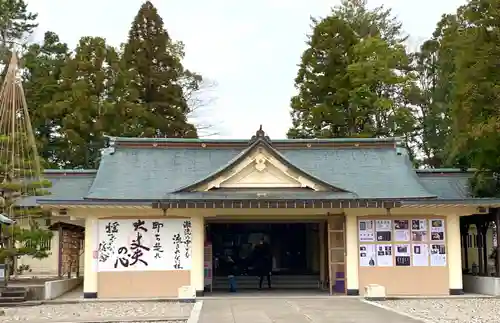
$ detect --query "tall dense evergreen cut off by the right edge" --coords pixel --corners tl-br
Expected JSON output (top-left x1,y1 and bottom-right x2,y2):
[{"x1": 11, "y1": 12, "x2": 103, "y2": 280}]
[{"x1": 442, "y1": 0, "x2": 500, "y2": 196}]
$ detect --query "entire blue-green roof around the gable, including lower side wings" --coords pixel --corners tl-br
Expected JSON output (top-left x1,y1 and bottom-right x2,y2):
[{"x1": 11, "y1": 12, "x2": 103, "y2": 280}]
[{"x1": 23, "y1": 134, "x2": 473, "y2": 205}]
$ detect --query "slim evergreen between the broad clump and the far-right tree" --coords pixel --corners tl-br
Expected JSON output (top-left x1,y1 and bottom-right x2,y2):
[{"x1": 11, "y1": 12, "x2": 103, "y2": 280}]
[{"x1": 408, "y1": 15, "x2": 459, "y2": 168}]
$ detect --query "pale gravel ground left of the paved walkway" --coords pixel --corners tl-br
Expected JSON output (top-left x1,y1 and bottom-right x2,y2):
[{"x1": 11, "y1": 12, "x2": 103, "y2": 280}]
[{"x1": 0, "y1": 302, "x2": 193, "y2": 323}]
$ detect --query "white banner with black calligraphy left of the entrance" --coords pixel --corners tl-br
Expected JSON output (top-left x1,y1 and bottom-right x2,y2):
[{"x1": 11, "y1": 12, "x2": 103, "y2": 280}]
[{"x1": 97, "y1": 219, "x2": 192, "y2": 271}]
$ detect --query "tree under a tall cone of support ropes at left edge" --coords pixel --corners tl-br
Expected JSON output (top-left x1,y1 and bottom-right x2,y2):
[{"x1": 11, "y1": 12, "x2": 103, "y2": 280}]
[{"x1": 0, "y1": 52, "x2": 52, "y2": 277}]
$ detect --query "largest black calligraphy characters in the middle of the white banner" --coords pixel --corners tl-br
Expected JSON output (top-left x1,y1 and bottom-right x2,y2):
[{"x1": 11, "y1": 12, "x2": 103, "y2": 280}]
[{"x1": 114, "y1": 220, "x2": 150, "y2": 268}]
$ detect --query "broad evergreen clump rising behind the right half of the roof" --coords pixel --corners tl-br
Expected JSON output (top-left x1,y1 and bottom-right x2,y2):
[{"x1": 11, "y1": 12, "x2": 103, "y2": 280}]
[{"x1": 288, "y1": 0, "x2": 414, "y2": 142}]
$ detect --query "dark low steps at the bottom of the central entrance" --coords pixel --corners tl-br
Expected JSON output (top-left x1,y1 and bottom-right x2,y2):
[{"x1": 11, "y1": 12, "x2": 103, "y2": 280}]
[{"x1": 213, "y1": 275, "x2": 320, "y2": 291}]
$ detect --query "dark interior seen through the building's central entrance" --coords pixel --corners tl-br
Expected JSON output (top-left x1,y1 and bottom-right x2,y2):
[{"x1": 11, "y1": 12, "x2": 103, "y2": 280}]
[{"x1": 207, "y1": 222, "x2": 319, "y2": 277}]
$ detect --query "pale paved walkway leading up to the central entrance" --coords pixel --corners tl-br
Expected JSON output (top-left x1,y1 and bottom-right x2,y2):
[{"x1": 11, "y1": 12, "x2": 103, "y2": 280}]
[{"x1": 199, "y1": 297, "x2": 420, "y2": 323}]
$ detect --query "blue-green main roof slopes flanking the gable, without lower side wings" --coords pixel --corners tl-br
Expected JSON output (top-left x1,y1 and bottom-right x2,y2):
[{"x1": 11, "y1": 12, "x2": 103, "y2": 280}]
[{"x1": 86, "y1": 140, "x2": 435, "y2": 200}]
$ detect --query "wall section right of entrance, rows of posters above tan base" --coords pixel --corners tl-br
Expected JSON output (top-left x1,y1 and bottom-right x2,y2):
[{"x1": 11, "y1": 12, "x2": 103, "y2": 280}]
[{"x1": 357, "y1": 215, "x2": 449, "y2": 295}]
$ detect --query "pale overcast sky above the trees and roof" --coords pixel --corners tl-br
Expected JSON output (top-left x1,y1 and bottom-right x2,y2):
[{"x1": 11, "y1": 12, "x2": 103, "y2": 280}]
[{"x1": 28, "y1": 0, "x2": 465, "y2": 139}]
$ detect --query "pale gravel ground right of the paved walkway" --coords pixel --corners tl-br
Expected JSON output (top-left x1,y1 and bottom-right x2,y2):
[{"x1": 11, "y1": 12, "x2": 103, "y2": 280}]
[{"x1": 379, "y1": 298, "x2": 500, "y2": 323}]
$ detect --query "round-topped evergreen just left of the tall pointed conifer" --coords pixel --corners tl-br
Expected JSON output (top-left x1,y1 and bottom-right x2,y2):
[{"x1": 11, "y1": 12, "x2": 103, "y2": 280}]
[{"x1": 51, "y1": 37, "x2": 118, "y2": 168}]
